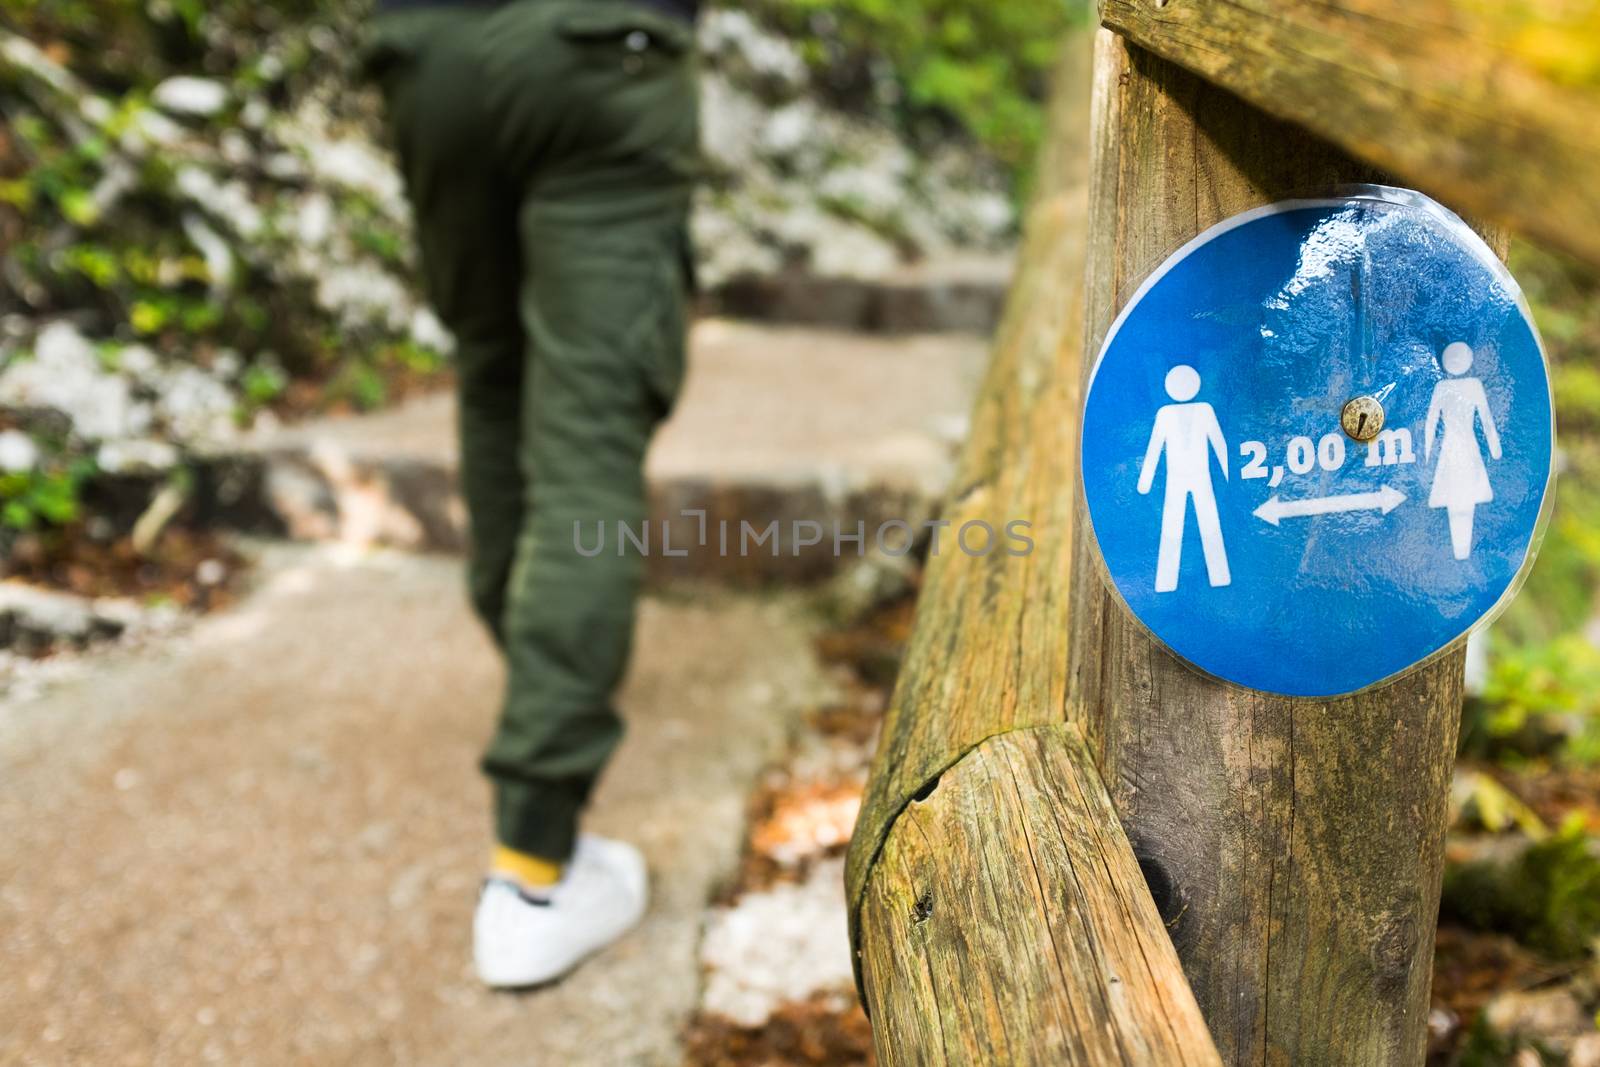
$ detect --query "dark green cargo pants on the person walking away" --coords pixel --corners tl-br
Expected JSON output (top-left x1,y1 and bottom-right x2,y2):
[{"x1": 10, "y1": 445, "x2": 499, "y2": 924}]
[{"x1": 365, "y1": 0, "x2": 698, "y2": 861}]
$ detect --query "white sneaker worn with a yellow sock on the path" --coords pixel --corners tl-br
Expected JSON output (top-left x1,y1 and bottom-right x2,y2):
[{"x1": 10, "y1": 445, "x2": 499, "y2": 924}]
[{"x1": 472, "y1": 833, "x2": 650, "y2": 989}]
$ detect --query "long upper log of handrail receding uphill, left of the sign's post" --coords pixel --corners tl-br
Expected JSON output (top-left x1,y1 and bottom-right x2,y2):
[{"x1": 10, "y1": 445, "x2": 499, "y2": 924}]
[{"x1": 846, "y1": 34, "x2": 1090, "y2": 934}]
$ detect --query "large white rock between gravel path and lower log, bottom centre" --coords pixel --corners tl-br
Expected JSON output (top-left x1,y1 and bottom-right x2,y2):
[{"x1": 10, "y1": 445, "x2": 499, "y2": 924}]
[{"x1": 701, "y1": 861, "x2": 854, "y2": 1027}]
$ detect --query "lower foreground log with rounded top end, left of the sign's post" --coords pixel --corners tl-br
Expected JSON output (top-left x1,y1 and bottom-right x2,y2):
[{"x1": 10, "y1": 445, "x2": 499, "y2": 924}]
[{"x1": 861, "y1": 723, "x2": 1221, "y2": 1067}]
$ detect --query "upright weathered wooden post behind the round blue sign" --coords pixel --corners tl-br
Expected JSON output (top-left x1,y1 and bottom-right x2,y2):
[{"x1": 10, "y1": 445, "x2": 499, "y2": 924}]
[{"x1": 1075, "y1": 35, "x2": 1461, "y2": 1065}]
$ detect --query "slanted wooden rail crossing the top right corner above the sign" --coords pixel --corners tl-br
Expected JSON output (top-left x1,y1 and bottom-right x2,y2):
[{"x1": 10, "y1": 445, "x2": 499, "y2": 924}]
[{"x1": 1101, "y1": 0, "x2": 1600, "y2": 262}]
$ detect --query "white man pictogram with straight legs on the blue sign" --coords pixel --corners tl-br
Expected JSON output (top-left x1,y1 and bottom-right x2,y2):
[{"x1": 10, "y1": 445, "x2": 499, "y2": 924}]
[{"x1": 1139, "y1": 365, "x2": 1234, "y2": 593}]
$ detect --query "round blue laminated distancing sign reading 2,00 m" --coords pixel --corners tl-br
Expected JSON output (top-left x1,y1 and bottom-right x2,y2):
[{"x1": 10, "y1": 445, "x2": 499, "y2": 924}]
[{"x1": 1083, "y1": 187, "x2": 1555, "y2": 697}]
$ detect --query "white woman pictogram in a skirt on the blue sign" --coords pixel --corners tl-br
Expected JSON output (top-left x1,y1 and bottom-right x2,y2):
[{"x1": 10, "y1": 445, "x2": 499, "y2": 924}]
[{"x1": 1422, "y1": 341, "x2": 1501, "y2": 560}]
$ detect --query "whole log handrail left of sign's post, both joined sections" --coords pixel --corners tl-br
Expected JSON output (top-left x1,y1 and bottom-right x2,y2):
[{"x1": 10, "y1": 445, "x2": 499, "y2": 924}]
[{"x1": 846, "y1": 37, "x2": 1221, "y2": 1065}]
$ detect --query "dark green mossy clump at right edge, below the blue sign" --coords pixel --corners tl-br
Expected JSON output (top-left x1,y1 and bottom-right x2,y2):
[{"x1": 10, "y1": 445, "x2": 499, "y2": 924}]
[{"x1": 1440, "y1": 816, "x2": 1600, "y2": 960}]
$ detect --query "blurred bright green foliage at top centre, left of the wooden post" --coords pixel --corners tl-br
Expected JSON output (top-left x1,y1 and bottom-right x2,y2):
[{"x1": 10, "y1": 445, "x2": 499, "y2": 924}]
[{"x1": 752, "y1": 0, "x2": 1090, "y2": 170}]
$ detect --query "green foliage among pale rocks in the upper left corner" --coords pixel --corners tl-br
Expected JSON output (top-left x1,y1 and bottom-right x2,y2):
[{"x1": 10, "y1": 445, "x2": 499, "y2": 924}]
[{"x1": 0, "y1": 0, "x2": 440, "y2": 418}]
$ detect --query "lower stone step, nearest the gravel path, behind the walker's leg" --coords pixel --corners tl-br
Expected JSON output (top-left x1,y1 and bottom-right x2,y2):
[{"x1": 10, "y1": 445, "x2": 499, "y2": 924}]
[{"x1": 198, "y1": 318, "x2": 986, "y2": 584}]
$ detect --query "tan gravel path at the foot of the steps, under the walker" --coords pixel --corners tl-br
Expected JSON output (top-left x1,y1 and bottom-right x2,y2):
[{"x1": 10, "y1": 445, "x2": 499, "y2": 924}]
[{"x1": 0, "y1": 547, "x2": 822, "y2": 1065}]
